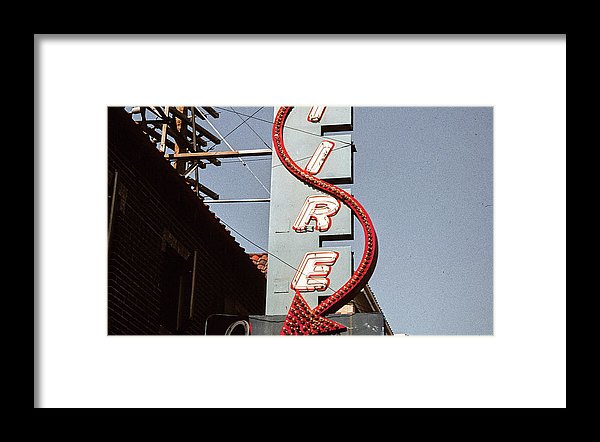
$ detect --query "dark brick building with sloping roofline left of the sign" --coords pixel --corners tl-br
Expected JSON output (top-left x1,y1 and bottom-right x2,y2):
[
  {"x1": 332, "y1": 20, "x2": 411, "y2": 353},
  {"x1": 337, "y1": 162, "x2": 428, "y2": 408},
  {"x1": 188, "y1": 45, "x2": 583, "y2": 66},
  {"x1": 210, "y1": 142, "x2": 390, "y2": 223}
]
[{"x1": 108, "y1": 108, "x2": 265, "y2": 335}]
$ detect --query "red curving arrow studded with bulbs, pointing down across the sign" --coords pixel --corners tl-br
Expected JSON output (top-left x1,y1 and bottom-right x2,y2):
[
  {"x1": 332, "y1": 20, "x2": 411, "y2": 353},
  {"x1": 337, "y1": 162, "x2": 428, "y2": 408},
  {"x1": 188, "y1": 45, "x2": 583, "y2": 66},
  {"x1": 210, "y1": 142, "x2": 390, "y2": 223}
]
[{"x1": 272, "y1": 106, "x2": 377, "y2": 335}]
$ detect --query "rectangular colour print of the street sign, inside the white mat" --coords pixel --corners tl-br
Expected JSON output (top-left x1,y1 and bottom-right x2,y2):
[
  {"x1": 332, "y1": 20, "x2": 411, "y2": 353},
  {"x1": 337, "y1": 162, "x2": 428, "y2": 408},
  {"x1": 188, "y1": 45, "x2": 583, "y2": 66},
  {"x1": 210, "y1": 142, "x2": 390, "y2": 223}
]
[{"x1": 107, "y1": 105, "x2": 493, "y2": 336}]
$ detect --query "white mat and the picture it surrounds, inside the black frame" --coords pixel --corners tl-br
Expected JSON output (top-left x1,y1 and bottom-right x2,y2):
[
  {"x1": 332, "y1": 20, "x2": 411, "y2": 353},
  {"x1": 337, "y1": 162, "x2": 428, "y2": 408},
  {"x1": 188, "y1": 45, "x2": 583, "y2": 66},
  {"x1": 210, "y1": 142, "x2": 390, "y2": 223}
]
[{"x1": 33, "y1": 33, "x2": 566, "y2": 409}]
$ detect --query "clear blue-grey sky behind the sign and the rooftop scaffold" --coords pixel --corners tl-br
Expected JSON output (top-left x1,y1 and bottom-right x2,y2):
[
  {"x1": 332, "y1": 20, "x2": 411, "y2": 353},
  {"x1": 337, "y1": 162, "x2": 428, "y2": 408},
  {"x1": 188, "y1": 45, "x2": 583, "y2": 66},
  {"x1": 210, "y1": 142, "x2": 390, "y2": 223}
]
[{"x1": 201, "y1": 106, "x2": 493, "y2": 335}]
